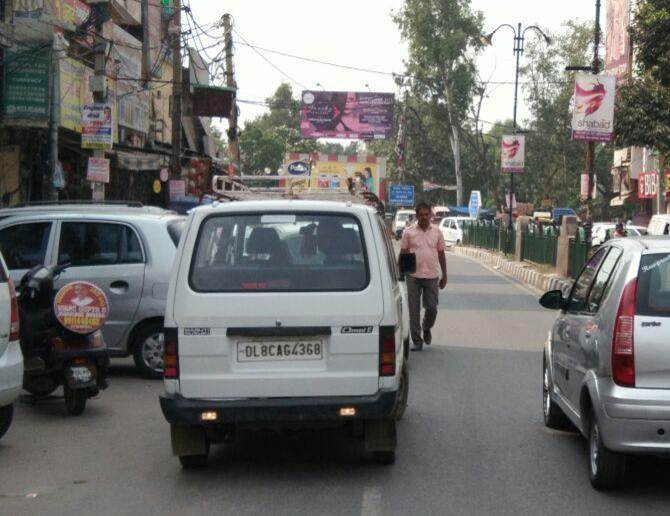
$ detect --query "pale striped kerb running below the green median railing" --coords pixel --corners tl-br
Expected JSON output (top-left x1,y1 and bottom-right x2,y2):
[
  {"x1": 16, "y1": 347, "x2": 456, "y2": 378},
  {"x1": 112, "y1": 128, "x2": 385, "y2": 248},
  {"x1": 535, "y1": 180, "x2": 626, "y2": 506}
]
[{"x1": 452, "y1": 246, "x2": 572, "y2": 296}]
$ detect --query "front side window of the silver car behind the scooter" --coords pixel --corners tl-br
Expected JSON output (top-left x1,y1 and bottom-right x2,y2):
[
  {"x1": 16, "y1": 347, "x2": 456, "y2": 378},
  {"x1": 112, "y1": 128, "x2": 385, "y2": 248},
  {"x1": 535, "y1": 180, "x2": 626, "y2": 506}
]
[{"x1": 0, "y1": 222, "x2": 51, "y2": 270}]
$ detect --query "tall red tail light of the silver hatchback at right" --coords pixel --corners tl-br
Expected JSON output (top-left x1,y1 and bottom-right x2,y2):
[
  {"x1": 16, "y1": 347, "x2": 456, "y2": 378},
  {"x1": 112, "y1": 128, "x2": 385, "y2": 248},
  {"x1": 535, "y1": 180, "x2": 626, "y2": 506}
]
[{"x1": 612, "y1": 280, "x2": 637, "y2": 387}]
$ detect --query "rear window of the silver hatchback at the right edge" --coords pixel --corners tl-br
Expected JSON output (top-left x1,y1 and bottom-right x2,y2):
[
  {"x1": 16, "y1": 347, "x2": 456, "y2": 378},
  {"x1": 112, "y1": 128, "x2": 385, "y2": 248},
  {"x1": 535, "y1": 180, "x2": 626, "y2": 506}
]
[{"x1": 636, "y1": 253, "x2": 670, "y2": 317}]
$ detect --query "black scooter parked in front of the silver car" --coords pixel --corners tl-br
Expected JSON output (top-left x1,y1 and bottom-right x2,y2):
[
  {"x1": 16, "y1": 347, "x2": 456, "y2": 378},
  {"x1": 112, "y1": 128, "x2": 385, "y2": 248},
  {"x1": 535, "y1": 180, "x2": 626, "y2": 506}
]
[{"x1": 17, "y1": 264, "x2": 109, "y2": 416}]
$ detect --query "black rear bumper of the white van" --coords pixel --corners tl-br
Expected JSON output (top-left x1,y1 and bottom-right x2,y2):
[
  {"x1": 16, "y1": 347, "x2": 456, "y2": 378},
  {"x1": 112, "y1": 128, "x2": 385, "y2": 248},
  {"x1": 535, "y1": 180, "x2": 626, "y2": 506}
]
[{"x1": 160, "y1": 391, "x2": 396, "y2": 426}]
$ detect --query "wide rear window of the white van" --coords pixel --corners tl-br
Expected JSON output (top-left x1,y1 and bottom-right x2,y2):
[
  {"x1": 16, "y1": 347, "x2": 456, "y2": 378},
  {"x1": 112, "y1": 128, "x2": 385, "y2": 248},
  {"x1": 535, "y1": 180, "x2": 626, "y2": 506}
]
[{"x1": 189, "y1": 213, "x2": 370, "y2": 292}]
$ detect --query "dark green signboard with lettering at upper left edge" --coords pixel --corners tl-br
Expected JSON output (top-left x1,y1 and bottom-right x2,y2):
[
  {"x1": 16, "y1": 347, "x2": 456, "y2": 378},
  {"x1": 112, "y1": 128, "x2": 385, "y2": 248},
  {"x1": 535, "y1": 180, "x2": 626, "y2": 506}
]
[{"x1": 2, "y1": 47, "x2": 51, "y2": 124}]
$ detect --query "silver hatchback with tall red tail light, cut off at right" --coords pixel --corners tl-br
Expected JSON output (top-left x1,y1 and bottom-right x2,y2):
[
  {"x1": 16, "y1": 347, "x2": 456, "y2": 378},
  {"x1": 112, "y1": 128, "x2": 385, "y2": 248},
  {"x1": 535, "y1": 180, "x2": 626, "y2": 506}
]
[{"x1": 540, "y1": 237, "x2": 670, "y2": 489}]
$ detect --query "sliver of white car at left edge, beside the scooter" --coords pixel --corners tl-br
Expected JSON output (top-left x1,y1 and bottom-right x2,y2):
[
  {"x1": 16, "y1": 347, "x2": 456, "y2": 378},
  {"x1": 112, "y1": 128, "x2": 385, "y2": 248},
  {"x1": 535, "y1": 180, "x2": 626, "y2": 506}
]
[{"x1": 0, "y1": 252, "x2": 23, "y2": 438}]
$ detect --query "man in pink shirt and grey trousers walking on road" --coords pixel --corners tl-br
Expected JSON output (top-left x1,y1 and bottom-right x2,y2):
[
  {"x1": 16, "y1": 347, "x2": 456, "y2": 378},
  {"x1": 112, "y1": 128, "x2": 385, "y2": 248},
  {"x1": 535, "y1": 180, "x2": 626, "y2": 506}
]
[{"x1": 400, "y1": 203, "x2": 447, "y2": 351}]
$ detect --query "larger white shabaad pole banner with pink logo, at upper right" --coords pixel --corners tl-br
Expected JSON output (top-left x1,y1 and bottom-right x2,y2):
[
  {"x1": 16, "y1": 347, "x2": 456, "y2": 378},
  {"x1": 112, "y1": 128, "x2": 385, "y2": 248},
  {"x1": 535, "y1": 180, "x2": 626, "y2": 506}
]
[{"x1": 572, "y1": 73, "x2": 616, "y2": 142}]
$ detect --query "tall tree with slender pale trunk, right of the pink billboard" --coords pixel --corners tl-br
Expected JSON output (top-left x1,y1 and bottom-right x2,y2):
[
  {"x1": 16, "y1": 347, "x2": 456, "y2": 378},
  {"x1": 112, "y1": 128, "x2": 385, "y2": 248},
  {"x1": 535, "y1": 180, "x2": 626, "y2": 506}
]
[{"x1": 394, "y1": 0, "x2": 482, "y2": 205}]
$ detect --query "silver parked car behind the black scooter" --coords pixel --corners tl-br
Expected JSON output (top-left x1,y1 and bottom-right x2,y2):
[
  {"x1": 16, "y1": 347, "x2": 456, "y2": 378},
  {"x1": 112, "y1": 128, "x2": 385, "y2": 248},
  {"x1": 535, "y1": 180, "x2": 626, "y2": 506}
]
[{"x1": 0, "y1": 207, "x2": 185, "y2": 378}]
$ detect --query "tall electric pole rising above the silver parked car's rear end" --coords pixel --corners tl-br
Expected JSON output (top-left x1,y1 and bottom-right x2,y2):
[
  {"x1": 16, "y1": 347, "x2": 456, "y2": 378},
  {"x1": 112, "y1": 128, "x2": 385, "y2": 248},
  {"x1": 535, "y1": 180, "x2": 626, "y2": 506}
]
[{"x1": 171, "y1": 0, "x2": 183, "y2": 204}]
